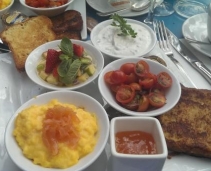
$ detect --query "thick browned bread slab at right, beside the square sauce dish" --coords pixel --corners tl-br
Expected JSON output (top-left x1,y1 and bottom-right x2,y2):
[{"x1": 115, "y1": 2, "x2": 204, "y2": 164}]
[{"x1": 157, "y1": 87, "x2": 211, "y2": 158}]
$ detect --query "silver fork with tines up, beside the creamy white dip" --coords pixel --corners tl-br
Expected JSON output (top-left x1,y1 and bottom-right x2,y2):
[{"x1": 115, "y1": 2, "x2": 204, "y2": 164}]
[{"x1": 153, "y1": 21, "x2": 195, "y2": 87}]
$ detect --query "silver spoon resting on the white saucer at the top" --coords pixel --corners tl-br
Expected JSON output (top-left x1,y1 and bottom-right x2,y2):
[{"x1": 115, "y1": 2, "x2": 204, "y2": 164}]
[{"x1": 97, "y1": 0, "x2": 150, "y2": 17}]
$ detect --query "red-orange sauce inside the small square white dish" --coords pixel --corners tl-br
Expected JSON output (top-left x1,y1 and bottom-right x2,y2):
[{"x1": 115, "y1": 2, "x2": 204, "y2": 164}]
[{"x1": 115, "y1": 131, "x2": 157, "y2": 154}]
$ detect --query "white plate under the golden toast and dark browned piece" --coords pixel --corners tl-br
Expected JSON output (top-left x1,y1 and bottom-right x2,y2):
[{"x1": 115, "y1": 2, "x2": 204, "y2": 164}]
[{"x1": 0, "y1": 0, "x2": 87, "y2": 40}]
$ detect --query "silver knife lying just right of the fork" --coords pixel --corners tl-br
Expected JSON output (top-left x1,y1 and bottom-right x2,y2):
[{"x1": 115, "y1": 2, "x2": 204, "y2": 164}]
[{"x1": 167, "y1": 29, "x2": 211, "y2": 84}]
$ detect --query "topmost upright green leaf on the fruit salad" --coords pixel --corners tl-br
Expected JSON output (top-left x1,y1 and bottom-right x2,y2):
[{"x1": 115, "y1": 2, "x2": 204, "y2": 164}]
[{"x1": 59, "y1": 37, "x2": 73, "y2": 57}]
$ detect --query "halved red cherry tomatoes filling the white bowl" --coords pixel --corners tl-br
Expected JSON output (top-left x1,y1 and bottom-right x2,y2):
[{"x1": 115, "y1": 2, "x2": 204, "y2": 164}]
[{"x1": 104, "y1": 60, "x2": 172, "y2": 112}]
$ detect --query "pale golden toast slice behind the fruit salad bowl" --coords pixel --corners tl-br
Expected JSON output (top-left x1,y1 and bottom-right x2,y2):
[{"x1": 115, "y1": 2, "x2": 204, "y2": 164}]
[{"x1": 0, "y1": 16, "x2": 56, "y2": 71}]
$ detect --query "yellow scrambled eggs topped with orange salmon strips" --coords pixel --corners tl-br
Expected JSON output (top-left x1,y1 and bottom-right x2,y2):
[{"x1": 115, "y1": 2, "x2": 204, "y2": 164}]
[{"x1": 13, "y1": 99, "x2": 98, "y2": 169}]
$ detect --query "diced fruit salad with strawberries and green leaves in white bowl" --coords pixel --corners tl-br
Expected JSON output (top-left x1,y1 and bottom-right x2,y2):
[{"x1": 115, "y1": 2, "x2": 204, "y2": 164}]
[{"x1": 37, "y1": 38, "x2": 96, "y2": 86}]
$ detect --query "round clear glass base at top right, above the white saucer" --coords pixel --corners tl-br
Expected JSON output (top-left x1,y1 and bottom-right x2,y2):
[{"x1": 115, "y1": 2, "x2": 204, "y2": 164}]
[{"x1": 174, "y1": 0, "x2": 207, "y2": 18}]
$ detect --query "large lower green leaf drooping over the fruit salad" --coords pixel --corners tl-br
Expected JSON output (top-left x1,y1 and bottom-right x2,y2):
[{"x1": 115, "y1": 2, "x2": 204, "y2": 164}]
[{"x1": 61, "y1": 59, "x2": 81, "y2": 84}]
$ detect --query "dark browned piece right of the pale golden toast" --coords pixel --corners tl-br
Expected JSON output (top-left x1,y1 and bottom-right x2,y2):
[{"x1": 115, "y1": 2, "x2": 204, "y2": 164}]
[{"x1": 50, "y1": 10, "x2": 83, "y2": 40}]
